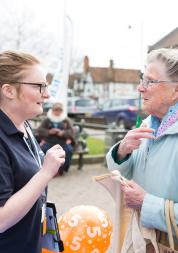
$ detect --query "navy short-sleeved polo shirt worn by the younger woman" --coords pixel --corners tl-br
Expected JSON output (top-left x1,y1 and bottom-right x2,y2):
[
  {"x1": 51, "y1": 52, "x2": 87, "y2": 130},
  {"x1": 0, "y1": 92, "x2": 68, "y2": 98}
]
[{"x1": 0, "y1": 110, "x2": 42, "y2": 253}]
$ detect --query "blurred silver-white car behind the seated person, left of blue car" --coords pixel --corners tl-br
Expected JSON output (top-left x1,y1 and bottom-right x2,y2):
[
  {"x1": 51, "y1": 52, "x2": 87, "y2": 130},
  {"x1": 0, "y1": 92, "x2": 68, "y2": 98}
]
[{"x1": 67, "y1": 97, "x2": 98, "y2": 117}]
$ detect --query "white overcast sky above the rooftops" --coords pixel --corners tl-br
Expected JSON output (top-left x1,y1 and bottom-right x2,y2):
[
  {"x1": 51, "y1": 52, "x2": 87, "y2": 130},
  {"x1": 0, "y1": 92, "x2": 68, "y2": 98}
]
[{"x1": 0, "y1": 0, "x2": 178, "y2": 68}]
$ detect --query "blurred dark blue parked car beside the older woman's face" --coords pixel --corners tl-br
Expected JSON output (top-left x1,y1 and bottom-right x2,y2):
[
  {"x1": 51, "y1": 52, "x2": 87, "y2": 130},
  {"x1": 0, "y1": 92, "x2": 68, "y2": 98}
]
[{"x1": 92, "y1": 97, "x2": 138, "y2": 129}]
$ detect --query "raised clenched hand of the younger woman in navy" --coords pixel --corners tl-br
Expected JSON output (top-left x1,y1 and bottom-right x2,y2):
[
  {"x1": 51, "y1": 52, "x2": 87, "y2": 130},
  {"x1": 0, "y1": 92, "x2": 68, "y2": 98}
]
[{"x1": 42, "y1": 144, "x2": 65, "y2": 178}]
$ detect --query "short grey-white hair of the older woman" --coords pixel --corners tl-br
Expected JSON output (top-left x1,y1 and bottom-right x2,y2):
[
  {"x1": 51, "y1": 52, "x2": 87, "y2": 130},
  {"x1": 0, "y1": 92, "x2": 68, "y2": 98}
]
[{"x1": 146, "y1": 48, "x2": 178, "y2": 78}]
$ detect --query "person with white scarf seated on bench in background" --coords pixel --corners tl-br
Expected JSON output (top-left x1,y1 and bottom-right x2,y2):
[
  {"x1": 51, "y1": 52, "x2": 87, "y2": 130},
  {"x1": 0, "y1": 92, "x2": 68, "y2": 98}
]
[{"x1": 37, "y1": 103, "x2": 75, "y2": 175}]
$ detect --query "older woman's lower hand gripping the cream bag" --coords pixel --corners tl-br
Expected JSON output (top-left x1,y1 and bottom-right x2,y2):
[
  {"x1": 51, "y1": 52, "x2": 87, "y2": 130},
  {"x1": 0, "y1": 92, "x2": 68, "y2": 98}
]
[{"x1": 121, "y1": 180, "x2": 146, "y2": 209}]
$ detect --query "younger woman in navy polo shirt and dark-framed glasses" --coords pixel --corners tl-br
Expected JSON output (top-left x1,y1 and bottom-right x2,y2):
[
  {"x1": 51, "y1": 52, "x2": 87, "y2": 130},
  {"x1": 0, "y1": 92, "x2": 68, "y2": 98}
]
[{"x1": 0, "y1": 51, "x2": 65, "y2": 253}]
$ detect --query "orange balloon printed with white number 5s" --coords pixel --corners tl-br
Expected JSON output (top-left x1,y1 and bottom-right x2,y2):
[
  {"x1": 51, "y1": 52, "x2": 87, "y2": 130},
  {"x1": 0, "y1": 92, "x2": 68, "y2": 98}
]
[{"x1": 58, "y1": 206, "x2": 112, "y2": 253}]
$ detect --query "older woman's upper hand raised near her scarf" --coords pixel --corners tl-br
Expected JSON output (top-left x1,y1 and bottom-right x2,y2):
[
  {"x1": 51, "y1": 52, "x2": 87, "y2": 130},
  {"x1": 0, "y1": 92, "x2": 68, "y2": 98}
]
[{"x1": 118, "y1": 127, "x2": 155, "y2": 160}]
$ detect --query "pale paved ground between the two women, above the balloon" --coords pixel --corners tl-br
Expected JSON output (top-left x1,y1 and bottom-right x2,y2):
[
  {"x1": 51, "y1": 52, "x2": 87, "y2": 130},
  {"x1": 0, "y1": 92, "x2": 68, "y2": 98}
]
[{"x1": 48, "y1": 164, "x2": 114, "y2": 253}]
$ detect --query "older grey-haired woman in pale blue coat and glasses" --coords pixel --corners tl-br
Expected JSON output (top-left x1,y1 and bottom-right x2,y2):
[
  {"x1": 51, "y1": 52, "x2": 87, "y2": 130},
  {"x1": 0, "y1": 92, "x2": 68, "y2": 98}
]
[{"x1": 107, "y1": 49, "x2": 178, "y2": 252}]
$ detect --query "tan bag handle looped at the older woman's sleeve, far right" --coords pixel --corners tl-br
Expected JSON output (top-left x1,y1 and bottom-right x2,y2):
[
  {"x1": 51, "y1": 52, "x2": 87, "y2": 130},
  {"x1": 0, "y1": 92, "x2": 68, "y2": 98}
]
[{"x1": 165, "y1": 199, "x2": 178, "y2": 250}]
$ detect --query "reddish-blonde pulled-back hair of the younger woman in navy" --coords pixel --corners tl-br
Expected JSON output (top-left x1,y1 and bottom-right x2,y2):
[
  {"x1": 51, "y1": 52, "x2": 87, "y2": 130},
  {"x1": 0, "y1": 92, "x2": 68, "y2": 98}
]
[{"x1": 0, "y1": 51, "x2": 40, "y2": 85}]
